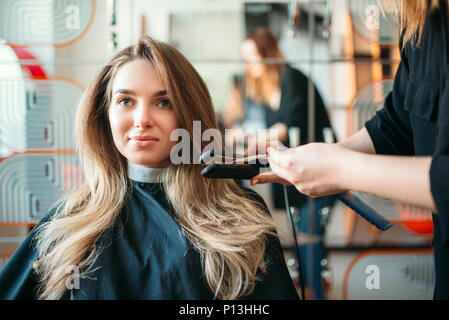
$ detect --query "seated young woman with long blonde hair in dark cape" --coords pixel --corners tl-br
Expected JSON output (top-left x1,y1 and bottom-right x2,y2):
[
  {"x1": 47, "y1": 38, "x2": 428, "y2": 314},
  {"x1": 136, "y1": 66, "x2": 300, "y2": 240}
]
[{"x1": 0, "y1": 37, "x2": 298, "y2": 299}]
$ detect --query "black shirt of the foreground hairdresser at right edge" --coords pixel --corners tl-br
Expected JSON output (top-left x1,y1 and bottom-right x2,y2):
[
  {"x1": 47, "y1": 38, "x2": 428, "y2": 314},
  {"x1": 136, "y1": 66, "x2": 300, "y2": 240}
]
[{"x1": 365, "y1": 1, "x2": 449, "y2": 299}]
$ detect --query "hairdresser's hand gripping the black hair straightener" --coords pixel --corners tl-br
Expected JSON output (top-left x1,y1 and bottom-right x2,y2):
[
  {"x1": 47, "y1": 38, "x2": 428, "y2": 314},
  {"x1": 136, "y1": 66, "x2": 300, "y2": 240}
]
[{"x1": 251, "y1": 143, "x2": 351, "y2": 197}]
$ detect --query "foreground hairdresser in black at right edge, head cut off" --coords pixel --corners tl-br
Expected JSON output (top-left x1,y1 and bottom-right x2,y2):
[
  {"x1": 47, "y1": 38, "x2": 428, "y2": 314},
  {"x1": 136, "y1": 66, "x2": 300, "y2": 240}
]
[{"x1": 253, "y1": 0, "x2": 449, "y2": 299}]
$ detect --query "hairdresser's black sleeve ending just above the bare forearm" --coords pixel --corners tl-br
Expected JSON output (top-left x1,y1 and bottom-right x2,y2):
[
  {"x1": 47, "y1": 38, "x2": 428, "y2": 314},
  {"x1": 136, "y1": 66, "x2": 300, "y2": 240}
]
[{"x1": 365, "y1": 62, "x2": 412, "y2": 155}]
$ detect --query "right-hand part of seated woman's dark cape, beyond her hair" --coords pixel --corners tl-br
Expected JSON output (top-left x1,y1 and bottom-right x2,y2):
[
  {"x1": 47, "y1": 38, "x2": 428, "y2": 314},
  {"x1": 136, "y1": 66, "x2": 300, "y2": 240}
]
[{"x1": 240, "y1": 189, "x2": 299, "y2": 300}]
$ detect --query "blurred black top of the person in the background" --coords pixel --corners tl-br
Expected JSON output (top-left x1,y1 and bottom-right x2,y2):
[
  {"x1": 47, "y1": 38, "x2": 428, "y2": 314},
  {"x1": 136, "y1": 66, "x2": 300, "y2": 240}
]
[{"x1": 264, "y1": 65, "x2": 336, "y2": 209}]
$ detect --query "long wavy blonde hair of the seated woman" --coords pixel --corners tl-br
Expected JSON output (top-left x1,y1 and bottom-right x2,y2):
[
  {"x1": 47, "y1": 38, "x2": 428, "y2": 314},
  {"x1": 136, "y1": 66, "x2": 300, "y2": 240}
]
[{"x1": 34, "y1": 37, "x2": 275, "y2": 299}]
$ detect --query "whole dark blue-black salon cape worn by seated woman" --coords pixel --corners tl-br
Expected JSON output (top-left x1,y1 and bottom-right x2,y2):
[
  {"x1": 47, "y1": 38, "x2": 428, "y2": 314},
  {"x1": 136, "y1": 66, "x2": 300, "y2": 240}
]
[{"x1": 0, "y1": 180, "x2": 298, "y2": 300}]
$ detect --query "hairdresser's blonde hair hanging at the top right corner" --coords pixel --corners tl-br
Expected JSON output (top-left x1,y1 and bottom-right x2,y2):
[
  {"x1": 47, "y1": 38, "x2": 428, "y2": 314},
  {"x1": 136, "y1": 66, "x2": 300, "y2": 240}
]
[{"x1": 378, "y1": 0, "x2": 440, "y2": 49}]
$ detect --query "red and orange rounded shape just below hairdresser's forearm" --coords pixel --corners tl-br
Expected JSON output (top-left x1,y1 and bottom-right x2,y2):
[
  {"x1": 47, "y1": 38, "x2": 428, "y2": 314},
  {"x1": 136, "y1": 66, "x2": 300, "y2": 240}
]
[{"x1": 398, "y1": 205, "x2": 433, "y2": 235}]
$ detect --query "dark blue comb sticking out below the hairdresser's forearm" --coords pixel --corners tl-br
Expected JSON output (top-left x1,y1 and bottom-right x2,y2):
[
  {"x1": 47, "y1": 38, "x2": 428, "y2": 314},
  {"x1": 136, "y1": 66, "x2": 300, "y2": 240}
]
[{"x1": 338, "y1": 192, "x2": 393, "y2": 231}]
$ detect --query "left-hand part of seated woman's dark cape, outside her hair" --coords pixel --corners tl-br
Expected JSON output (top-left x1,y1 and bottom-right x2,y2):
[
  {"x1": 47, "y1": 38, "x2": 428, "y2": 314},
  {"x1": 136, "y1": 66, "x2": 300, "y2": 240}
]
[{"x1": 0, "y1": 208, "x2": 55, "y2": 300}]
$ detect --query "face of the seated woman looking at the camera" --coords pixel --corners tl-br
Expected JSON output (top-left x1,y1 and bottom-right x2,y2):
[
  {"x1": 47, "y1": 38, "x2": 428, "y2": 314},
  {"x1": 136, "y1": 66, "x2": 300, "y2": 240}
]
[{"x1": 108, "y1": 60, "x2": 179, "y2": 168}]
